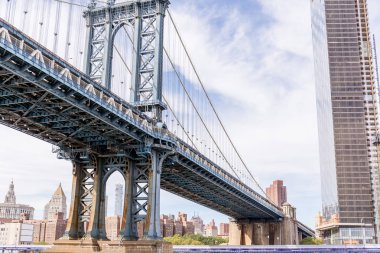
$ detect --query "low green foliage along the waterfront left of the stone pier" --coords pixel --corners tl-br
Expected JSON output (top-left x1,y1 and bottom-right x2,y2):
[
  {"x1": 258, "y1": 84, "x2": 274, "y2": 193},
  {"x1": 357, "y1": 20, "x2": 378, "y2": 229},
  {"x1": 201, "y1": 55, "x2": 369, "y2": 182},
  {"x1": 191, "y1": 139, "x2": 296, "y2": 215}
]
[{"x1": 164, "y1": 235, "x2": 228, "y2": 246}]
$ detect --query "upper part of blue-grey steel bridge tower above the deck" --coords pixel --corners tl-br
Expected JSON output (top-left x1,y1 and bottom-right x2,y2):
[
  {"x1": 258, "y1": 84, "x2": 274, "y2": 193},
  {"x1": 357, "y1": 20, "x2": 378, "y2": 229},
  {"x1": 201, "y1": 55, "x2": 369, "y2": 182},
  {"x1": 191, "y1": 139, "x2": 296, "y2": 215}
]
[{"x1": 84, "y1": 0, "x2": 169, "y2": 122}]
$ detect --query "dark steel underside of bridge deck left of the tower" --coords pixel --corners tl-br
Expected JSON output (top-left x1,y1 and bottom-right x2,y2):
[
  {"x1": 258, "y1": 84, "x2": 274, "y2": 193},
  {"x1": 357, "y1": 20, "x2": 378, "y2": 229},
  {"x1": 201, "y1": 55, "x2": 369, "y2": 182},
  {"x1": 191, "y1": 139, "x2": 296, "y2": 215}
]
[{"x1": 0, "y1": 52, "x2": 153, "y2": 152}]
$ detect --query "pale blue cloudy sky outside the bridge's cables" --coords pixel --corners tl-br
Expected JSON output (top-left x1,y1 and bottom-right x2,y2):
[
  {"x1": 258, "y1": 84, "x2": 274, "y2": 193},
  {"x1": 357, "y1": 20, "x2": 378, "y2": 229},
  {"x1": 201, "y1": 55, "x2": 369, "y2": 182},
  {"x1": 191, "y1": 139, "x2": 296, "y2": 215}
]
[{"x1": 0, "y1": 0, "x2": 380, "y2": 228}]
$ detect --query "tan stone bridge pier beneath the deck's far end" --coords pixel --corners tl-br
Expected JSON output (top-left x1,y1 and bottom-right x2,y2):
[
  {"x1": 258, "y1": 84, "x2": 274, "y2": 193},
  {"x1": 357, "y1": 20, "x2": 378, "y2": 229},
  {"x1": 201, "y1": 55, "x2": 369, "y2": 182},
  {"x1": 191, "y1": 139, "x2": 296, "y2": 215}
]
[{"x1": 229, "y1": 203, "x2": 299, "y2": 245}]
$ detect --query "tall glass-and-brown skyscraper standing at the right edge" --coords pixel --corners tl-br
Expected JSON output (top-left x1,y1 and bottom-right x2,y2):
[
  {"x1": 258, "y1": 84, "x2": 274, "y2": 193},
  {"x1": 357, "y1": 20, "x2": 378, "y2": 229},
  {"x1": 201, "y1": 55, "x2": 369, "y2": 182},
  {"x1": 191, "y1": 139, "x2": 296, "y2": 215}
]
[{"x1": 311, "y1": 0, "x2": 379, "y2": 244}]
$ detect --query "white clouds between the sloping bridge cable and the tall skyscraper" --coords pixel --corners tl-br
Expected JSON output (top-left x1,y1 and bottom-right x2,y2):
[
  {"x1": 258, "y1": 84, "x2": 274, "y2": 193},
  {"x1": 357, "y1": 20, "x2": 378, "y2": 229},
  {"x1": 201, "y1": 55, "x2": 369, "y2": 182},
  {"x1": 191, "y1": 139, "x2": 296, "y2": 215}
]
[{"x1": 169, "y1": 0, "x2": 320, "y2": 226}]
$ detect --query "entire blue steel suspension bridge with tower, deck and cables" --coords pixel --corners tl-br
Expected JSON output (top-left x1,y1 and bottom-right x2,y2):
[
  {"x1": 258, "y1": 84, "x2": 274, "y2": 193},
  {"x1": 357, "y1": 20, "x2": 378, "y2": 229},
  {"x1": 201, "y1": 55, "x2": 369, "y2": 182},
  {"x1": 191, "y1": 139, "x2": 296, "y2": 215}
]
[{"x1": 0, "y1": 0, "x2": 314, "y2": 251}]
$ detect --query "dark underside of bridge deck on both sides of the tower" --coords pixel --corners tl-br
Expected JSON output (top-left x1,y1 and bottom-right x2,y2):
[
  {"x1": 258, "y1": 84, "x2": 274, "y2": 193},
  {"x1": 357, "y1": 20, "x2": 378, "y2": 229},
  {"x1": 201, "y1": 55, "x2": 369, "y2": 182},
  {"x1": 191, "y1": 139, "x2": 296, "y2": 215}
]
[{"x1": 0, "y1": 52, "x2": 282, "y2": 219}]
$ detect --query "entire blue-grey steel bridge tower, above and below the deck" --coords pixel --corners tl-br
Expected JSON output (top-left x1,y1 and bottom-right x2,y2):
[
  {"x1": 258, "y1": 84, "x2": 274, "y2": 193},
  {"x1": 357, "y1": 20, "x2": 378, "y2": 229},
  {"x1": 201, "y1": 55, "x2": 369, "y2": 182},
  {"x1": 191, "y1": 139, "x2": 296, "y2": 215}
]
[{"x1": 47, "y1": 0, "x2": 173, "y2": 252}]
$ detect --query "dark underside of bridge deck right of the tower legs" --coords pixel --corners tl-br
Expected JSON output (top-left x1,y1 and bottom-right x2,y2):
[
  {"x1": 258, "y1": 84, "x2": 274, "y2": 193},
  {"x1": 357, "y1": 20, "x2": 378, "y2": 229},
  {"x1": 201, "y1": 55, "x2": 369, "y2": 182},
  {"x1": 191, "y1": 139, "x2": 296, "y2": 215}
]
[{"x1": 161, "y1": 161, "x2": 276, "y2": 220}]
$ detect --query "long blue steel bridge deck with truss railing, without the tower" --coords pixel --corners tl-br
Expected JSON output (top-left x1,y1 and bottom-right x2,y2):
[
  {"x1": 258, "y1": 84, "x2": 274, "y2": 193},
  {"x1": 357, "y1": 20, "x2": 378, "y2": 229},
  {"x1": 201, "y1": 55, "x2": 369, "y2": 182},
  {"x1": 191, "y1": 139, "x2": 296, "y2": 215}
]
[{"x1": 0, "y1": 17, "x2": 283, "y2": 220}]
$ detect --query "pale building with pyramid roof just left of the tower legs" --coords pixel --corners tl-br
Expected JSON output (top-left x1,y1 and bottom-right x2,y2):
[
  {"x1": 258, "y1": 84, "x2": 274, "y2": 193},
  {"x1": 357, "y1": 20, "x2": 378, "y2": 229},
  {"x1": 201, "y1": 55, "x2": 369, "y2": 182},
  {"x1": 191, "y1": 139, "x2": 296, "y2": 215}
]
[{"x1": 44, "y1": 184, "x2": 67, "y2": 220}]
